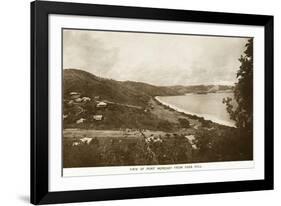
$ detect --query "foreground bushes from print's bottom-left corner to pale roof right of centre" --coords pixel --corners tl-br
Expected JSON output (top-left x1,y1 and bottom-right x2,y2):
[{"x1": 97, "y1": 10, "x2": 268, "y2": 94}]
[{"x1": 63, "y1": 134, "x2": 192, "y2": 168}]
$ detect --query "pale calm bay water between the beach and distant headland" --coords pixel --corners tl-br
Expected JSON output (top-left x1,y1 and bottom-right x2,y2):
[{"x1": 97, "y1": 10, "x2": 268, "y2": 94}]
[{"x1": 156, "y1": 93, "x2": 234, "y2": 126}]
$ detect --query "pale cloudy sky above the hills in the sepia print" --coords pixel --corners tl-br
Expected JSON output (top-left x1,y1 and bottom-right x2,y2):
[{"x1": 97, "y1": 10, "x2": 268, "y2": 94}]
[{"x1": 63, "y1": 29, "x2": 248, "y2": 86}]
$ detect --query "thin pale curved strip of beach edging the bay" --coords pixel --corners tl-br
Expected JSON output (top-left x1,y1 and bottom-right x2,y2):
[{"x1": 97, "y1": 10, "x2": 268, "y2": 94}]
[{"x1": 154, "y1": 96, "x2": 235, "y2": 127}]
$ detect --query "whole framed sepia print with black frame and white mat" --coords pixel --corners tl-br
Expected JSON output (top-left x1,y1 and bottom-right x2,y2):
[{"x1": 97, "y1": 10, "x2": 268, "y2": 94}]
[{"x1": 31, "y1": 1, "x2": 273, "y2": 204}]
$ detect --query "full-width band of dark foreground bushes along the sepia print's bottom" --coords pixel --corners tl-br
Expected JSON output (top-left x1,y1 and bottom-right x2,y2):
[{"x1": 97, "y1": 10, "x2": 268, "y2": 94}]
[{"x1": 63, "y1": 127, "x2": 252, "y2": 168}]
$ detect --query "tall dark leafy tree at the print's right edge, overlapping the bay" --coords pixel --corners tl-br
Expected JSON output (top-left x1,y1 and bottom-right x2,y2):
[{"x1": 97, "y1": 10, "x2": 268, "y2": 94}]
[{"x1": 223, "y1": 38, "x2": 253, "y2": 131}]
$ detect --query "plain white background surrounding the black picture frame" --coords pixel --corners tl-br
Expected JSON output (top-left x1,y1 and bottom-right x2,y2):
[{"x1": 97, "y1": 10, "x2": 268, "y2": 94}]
[{"x1": 0, "y1": 0, "x2": 281, "y2": 206}]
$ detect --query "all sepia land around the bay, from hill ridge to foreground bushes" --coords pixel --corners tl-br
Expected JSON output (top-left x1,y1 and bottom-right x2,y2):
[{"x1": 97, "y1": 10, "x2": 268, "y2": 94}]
[{"x1": 63, "y1": 67, "x2": 252, "y2": 168}]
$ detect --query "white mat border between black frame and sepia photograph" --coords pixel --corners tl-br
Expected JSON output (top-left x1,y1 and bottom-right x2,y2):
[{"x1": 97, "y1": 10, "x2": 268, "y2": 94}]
[{"x1": 49, "y1": 14, "x2": 264, "y2": 192}]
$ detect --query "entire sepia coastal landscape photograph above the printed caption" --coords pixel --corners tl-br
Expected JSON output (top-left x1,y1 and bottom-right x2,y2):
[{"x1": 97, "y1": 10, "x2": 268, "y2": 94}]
[{"x1": 62, "y1": 28, "x2": 254, "y2": 168}]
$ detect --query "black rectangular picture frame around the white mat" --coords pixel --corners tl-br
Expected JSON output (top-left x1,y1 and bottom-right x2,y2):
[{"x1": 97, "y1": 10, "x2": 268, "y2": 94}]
[{"x1": 30, "y1": 1, "x2": 273, "y2": 204}]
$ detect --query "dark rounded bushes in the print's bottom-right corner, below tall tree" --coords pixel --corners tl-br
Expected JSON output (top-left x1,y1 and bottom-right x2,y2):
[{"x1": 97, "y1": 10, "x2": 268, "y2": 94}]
[{"x1": 192, "y1": 127, "x2": 253, "y2": 162}]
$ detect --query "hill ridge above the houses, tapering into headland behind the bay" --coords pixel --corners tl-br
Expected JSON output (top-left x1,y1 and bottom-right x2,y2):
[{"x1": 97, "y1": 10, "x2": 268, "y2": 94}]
[{"x1": 63, "y1": 69, "x2": 232, "y2": 106}]
